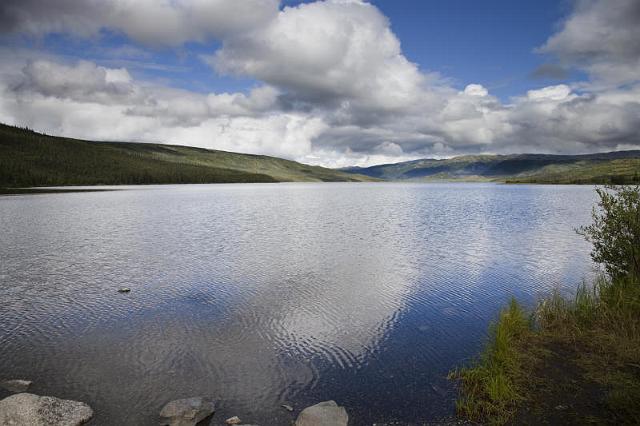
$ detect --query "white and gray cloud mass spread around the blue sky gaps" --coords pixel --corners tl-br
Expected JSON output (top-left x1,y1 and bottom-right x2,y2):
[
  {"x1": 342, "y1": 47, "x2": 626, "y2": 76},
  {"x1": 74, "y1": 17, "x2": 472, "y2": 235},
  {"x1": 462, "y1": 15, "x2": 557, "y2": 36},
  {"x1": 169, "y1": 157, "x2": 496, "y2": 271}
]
[{"x1": 0, "y1": 0, "x2": 640, "y2": 166}]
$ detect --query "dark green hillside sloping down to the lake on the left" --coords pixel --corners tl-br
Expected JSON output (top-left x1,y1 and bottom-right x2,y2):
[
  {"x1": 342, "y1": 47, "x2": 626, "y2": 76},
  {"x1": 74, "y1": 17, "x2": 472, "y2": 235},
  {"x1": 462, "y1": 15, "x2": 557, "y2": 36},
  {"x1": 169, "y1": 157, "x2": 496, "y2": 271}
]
[{"x1": 0, "y1": 124, "x2": 372, "y2": 188}]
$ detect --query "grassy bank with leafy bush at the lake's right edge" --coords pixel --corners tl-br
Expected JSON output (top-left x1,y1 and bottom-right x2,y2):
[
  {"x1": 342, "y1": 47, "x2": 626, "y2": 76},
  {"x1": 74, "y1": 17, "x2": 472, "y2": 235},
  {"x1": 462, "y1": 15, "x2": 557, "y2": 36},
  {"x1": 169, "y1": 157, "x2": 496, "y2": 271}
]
[{"x1": 449, "y1": 187, "x2": 640, "y2": 425}]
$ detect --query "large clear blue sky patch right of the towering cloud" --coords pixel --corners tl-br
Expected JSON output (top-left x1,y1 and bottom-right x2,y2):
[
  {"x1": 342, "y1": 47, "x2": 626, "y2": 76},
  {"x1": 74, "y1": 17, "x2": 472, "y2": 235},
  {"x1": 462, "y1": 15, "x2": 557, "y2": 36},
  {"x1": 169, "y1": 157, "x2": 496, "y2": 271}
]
[{"x1": 373, "y1": 0, "x2": 575, "y2": 99}]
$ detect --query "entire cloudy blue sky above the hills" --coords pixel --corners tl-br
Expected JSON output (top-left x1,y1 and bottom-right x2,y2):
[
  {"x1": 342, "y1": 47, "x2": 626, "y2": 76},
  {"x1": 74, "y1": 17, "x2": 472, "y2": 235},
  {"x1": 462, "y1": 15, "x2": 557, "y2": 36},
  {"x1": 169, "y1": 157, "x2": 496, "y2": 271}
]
[{"x1": 0, "y1": 0, "x2": 640, "y2": 167}]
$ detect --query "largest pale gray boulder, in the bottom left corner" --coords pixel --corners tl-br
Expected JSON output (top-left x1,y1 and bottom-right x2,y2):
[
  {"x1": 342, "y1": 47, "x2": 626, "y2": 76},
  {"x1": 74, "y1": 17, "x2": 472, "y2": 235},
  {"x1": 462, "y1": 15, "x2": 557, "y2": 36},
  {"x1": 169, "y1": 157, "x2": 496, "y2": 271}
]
[{"x1": 0, "y1": 393, "x2": 93, "y2": 426}]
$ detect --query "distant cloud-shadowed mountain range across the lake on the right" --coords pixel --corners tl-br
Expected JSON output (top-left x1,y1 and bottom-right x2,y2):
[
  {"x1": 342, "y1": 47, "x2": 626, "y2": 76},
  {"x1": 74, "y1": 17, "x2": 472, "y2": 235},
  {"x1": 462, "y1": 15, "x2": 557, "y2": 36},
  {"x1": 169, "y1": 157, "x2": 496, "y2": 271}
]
[{"x1": 341, "y1": 151, "x2": 640, "y2": 184}]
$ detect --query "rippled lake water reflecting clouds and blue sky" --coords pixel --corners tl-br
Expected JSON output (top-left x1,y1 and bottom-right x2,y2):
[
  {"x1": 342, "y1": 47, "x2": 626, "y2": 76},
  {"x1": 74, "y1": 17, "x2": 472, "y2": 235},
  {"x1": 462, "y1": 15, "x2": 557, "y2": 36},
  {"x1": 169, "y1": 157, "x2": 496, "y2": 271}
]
[{"x1": 0, "y1": 183, "x2": 596, "y2": 426}]
